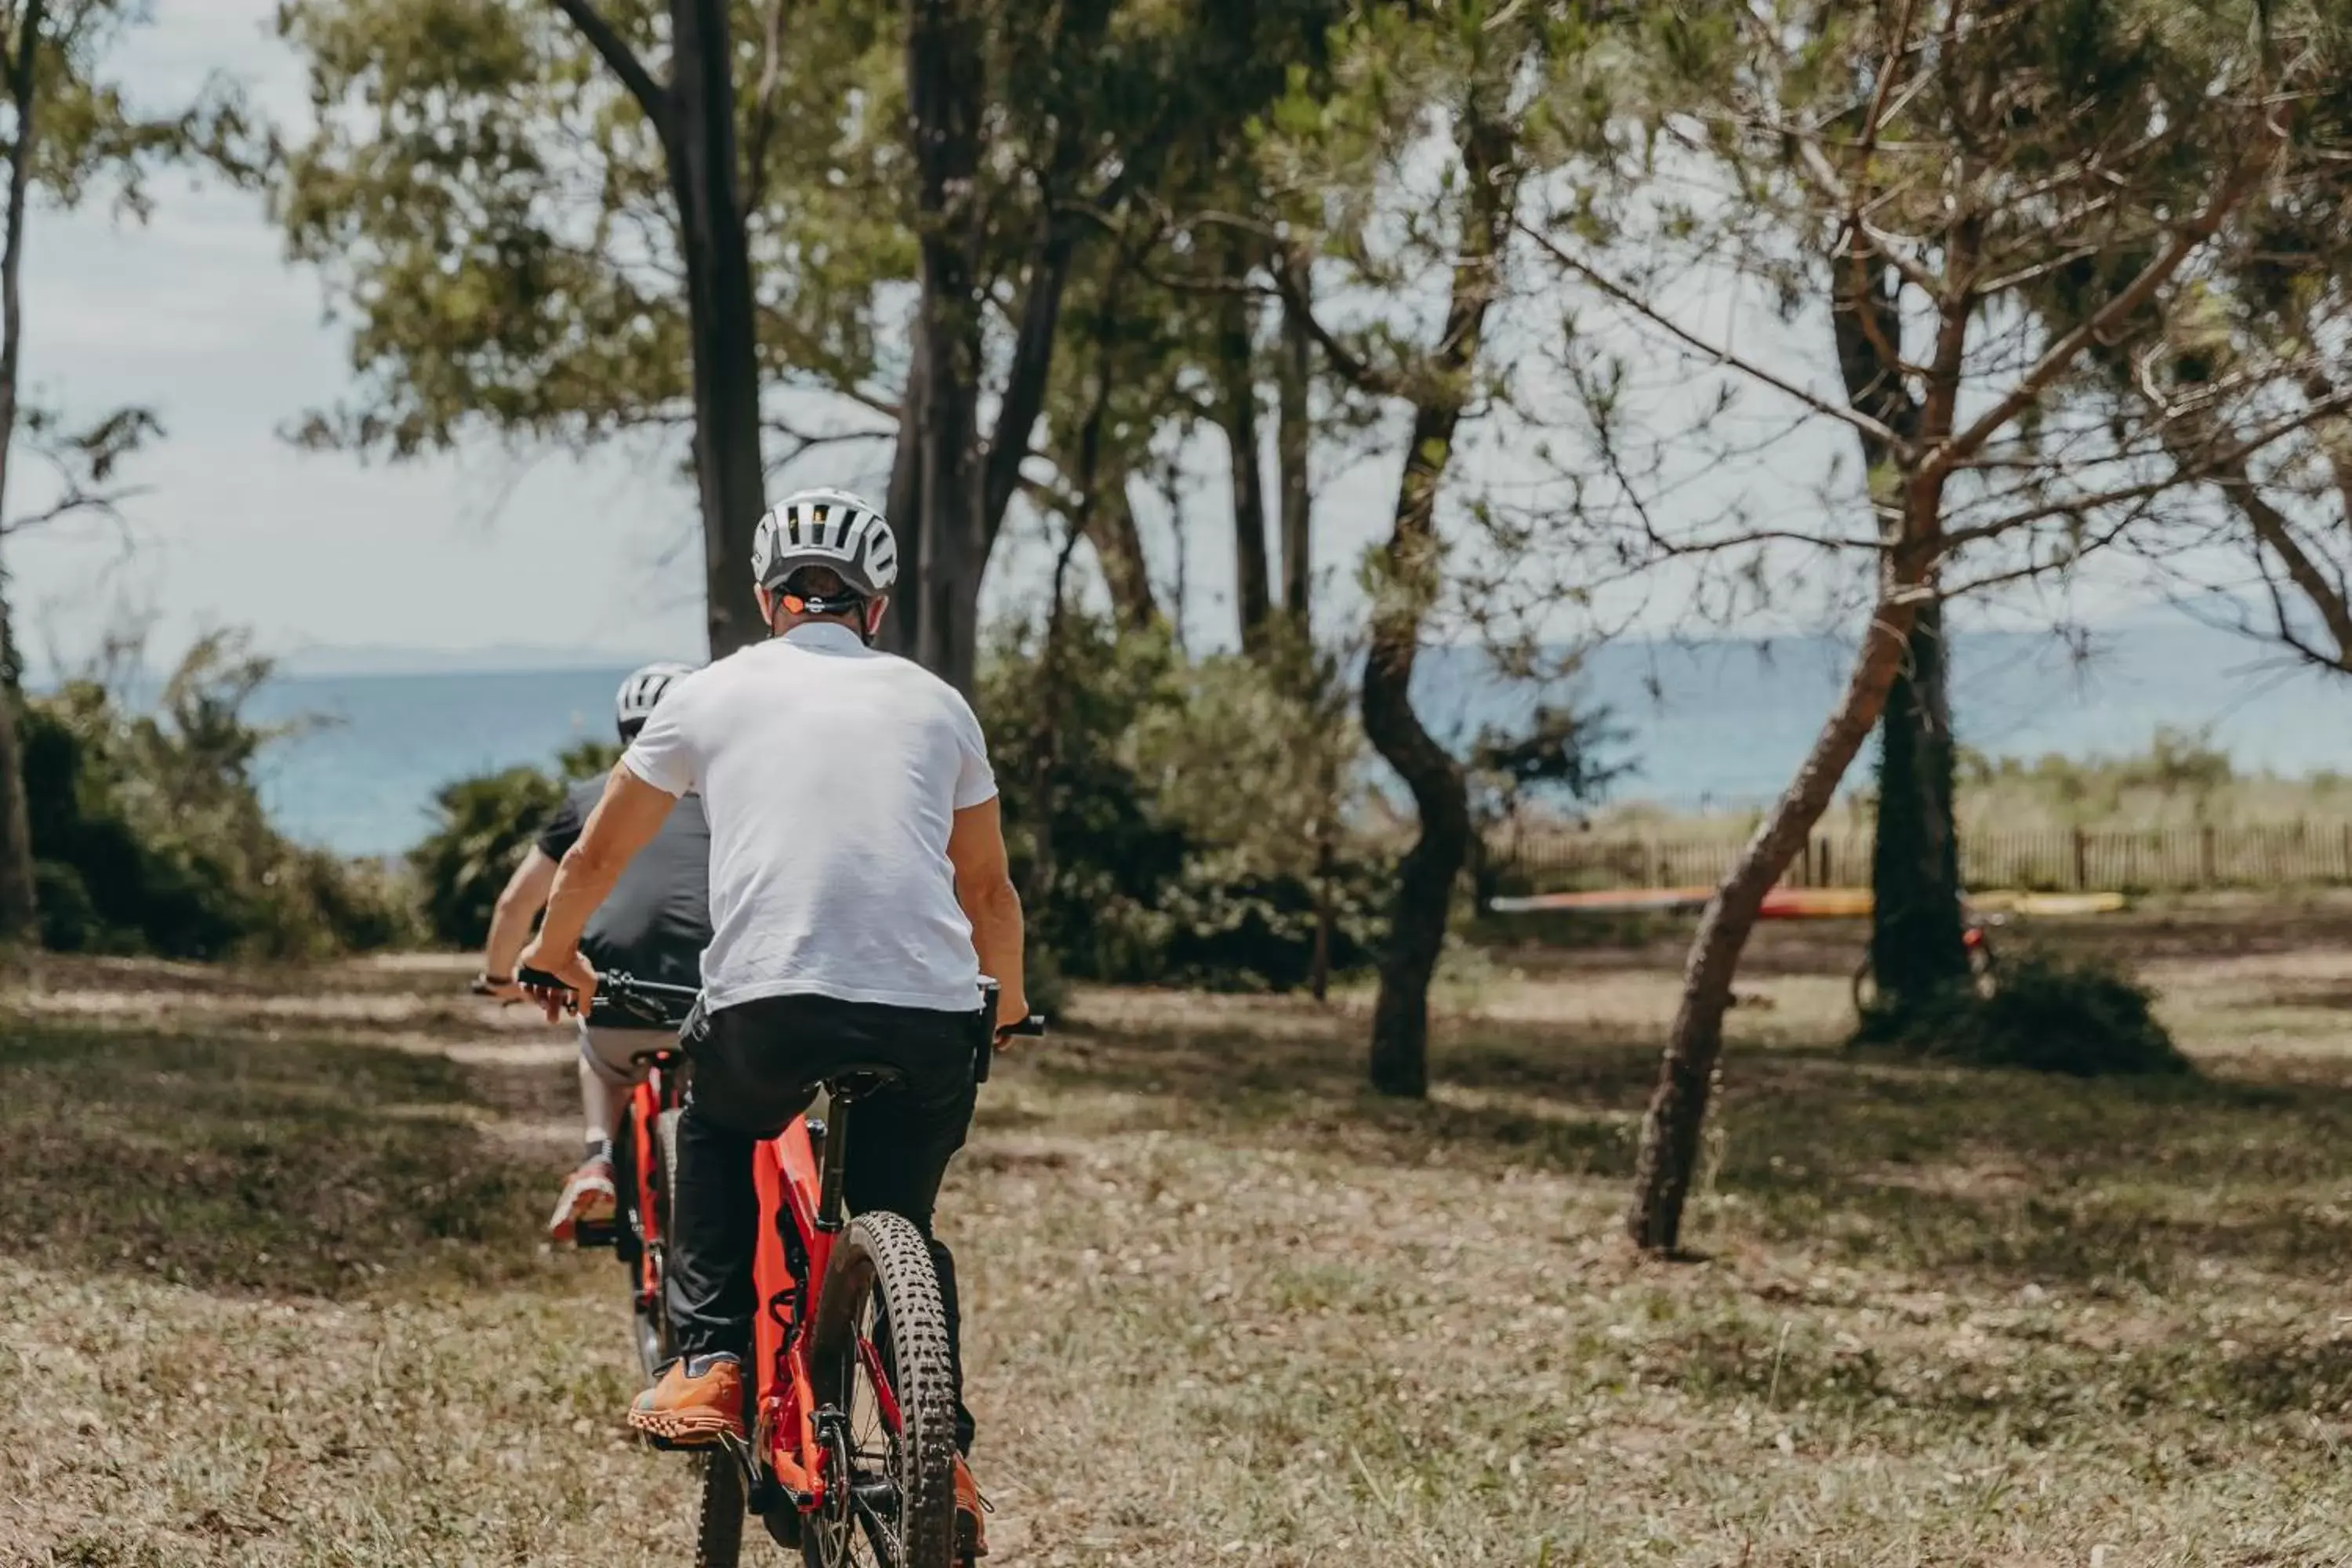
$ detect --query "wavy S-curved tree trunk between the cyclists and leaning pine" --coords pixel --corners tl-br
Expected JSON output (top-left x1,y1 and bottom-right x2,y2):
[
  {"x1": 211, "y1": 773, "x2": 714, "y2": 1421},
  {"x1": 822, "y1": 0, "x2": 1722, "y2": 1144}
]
[{"x1": 1362, "y1": 103, "x2": 1519, "y2": 1098}]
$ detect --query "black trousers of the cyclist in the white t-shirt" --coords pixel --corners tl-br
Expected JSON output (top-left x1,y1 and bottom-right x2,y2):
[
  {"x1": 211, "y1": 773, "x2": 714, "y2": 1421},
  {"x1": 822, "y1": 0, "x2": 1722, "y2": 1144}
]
[{"x1": 668, "y1": 996, "x2": 978, "y2": 1453}]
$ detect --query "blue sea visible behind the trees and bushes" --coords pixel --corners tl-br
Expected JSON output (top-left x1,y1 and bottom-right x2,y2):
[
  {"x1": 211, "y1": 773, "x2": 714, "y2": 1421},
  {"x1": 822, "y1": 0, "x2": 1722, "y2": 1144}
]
[{"x1": 234, "y1": 623, "x2": 2352, "y2": 855}]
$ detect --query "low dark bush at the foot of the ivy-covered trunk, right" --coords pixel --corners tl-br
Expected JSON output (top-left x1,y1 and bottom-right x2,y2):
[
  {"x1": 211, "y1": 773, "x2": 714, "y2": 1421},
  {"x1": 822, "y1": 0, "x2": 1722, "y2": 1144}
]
[{"x1": 1856, "y1": 952, "x2": 2194, "y2": 1079}]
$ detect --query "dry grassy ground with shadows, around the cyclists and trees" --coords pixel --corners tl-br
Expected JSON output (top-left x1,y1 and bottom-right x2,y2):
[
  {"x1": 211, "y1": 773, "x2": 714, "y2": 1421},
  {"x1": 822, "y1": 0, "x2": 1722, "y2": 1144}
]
[{"x1": 13, "y1": 942, "x2": 2352, "y2": 1568}]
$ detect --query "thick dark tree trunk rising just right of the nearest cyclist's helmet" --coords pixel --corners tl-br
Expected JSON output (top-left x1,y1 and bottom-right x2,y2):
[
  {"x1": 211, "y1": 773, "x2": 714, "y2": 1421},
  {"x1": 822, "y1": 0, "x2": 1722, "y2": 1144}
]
[{"x1": 901, "y1": 0, "x2": 985, "y2": 696}]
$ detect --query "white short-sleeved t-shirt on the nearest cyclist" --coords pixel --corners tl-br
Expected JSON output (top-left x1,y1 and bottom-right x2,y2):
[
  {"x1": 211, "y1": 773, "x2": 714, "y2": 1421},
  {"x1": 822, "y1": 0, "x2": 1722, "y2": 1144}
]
[{"x1": 621, "y1": 626, "x2": 997, "y2": 1013}]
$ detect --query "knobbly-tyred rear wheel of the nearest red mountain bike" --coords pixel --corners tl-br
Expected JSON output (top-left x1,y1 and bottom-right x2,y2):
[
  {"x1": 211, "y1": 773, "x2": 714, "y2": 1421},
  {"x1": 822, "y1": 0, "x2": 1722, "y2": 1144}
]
[{"x1": 802, "y1": 1213, "x2": 957, "y2": 1568}]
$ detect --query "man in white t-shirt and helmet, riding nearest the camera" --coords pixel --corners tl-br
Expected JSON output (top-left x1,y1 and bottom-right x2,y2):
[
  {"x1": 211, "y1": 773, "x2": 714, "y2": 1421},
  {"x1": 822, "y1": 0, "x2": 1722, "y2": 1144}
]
[{"x1": 522, "y1": 489, "x2": 1028, "y2": 1556}]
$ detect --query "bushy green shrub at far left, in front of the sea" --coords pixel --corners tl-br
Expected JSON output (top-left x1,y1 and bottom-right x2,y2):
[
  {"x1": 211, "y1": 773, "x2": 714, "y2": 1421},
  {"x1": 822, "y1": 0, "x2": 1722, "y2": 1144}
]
[{"x1": 21, "y1": 637, "x2": 414, "y2": 959}]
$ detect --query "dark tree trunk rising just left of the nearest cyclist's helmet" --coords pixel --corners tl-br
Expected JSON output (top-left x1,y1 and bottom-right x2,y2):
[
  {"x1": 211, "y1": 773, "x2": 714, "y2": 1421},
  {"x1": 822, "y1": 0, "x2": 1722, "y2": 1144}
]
[{"x1": 670, "y1": 0, "x2": 767, "y2": 659}]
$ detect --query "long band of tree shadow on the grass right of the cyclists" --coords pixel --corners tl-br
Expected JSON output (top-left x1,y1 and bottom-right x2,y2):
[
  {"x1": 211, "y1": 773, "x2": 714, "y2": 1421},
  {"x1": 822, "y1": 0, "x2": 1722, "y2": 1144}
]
[{"x1": 1033, "y1": 1018, "x2": 2352, "y2": 1293}]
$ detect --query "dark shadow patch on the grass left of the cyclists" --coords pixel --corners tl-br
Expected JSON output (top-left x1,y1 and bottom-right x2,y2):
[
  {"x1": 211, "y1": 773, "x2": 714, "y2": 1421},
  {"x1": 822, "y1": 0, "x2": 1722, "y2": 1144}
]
[{"x1": 0, "y1": 1022, "x2": 546, "y2": 1295}]
